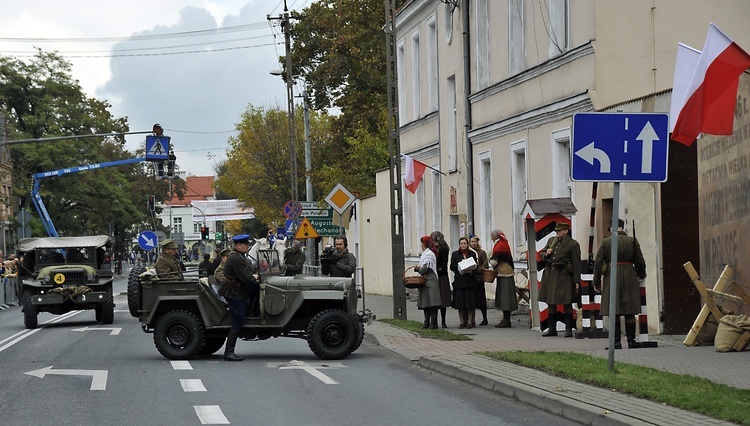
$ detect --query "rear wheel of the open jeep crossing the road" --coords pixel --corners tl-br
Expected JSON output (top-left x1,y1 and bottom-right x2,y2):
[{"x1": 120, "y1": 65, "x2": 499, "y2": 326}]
[{"x1": 154, "y1": 310, "x2": 206, "y2": 359}]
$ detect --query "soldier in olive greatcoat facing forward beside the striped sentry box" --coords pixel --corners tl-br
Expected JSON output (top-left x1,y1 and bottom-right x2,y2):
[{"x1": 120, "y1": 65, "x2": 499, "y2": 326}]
[{"x1": 539, "y1": 223, "x2": 581, "y2": 337}]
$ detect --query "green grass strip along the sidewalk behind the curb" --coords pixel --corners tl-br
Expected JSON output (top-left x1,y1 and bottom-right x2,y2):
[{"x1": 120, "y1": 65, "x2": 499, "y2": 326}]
[{"x1": 477, "y1": 351, "x2": 750, "y2": 426}]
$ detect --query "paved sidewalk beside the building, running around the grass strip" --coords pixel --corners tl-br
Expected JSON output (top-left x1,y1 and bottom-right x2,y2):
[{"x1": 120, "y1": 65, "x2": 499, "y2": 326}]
[{"x1": 360, "y1": 294, "x2": 750, "y2": 426}]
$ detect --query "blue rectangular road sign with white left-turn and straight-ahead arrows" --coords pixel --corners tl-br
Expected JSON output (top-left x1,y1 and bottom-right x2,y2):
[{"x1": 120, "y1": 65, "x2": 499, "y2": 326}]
[{"x1": 571, "y1": 112, "x2": 669, "y2": 182}]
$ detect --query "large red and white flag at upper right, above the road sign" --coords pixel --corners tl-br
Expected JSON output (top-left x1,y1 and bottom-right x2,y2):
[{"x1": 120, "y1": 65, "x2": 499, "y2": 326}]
[{"x1": 670, "y1": 24, "x2": 750, "y2": 146}]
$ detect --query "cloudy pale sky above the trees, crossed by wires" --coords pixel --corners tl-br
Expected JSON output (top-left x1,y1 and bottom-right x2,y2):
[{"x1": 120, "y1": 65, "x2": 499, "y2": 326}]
[{"x1": 0, "y1": 0, "x2": 313, "y2": 176}]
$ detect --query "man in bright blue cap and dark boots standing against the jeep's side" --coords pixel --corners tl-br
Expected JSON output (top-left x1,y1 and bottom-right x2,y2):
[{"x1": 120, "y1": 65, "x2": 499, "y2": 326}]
[{"x1": 219, "y1": 234, "x2": 260, "y2": 361}]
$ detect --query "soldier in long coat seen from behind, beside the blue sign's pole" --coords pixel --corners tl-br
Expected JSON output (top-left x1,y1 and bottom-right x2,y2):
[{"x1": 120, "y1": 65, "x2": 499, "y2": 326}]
[{"x1": 594, "y1": 219, "x2": 646, "y2": 349}]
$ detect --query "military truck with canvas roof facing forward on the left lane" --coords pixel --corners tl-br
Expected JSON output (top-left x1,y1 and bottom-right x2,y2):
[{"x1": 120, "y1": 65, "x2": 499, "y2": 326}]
[{"x1": 16, "y1": 235, "x2": 115, "y2": 329}]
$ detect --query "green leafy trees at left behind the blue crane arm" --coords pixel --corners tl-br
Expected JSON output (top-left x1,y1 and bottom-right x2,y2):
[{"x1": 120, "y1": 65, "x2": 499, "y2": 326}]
[{"x1": 0, "y1": 50, "x2": 172, "y2": 251}]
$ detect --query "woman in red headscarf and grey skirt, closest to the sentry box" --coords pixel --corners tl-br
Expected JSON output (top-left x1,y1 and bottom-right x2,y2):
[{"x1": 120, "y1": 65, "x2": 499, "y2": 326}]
[{"x1": 489, "y1": 229, "x2": 518, "y2": 328}]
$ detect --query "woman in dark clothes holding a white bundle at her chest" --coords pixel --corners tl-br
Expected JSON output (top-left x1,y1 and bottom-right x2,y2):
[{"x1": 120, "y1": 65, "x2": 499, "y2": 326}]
[{"x1": 450, "y1": 237, "x2": 477, "y2": 328}]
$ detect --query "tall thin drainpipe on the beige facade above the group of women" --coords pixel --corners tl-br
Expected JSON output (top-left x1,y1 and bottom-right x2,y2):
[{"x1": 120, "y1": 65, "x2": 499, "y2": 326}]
[{"x1": 461, "y1": 0, "x2": 474, "y2": 234}]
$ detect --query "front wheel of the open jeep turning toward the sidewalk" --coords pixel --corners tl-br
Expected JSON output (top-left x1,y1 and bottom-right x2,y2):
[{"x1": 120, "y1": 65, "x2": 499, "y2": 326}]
[{"x1": 307, "y1": 309, "x2": 358, "y2": 359}]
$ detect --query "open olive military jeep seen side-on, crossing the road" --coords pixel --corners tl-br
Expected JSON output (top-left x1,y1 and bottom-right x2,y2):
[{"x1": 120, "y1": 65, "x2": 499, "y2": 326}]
[{"x1": 128, "y1": 250, "x2": 373, "y2": 359}]
